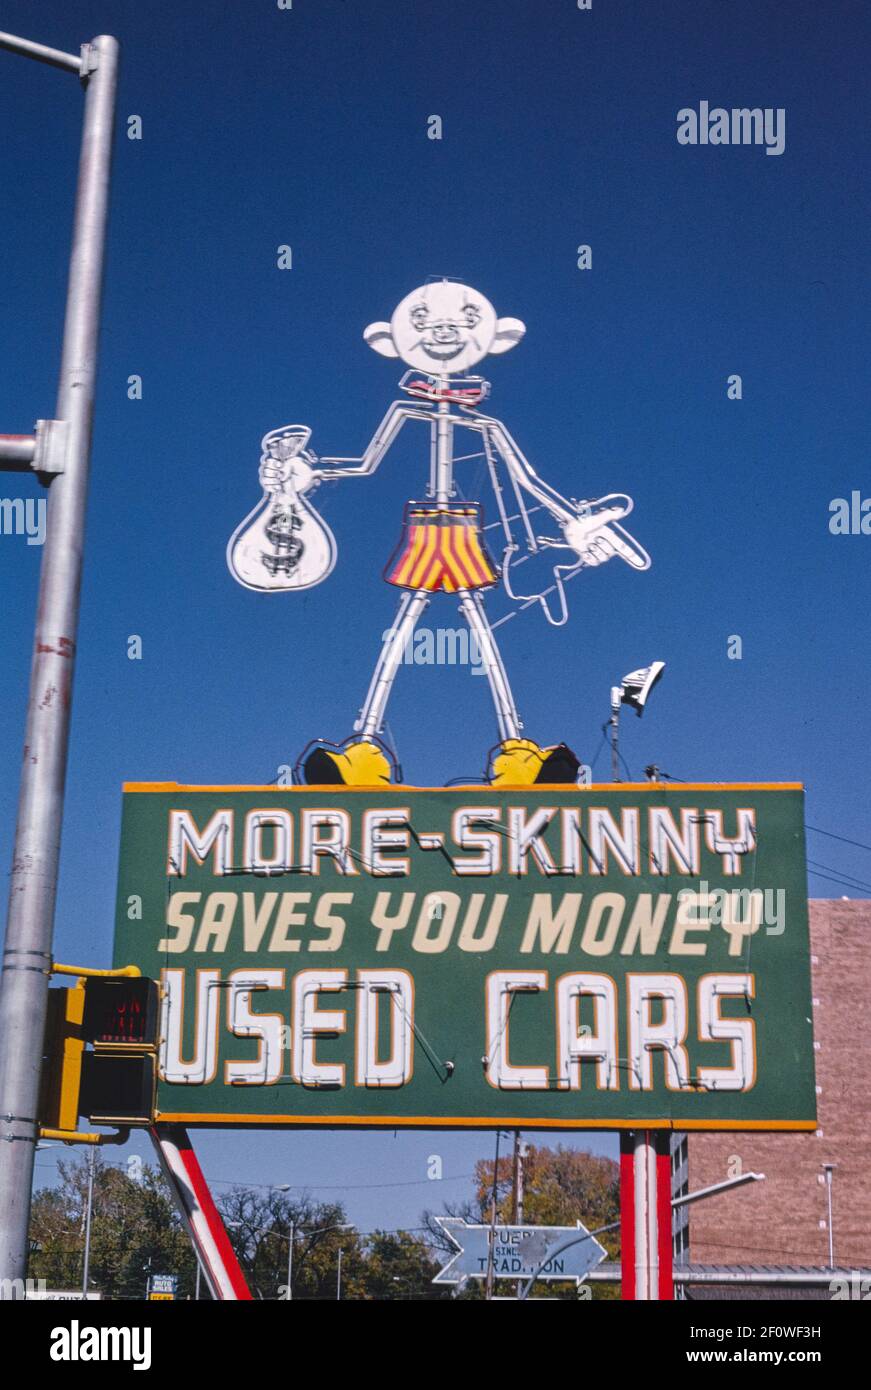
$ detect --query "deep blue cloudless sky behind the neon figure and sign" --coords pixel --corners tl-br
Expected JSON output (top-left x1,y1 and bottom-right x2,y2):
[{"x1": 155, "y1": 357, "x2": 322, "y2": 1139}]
[{"x1": 0, "y1": 0, "x2": 871, "y2": 1226}]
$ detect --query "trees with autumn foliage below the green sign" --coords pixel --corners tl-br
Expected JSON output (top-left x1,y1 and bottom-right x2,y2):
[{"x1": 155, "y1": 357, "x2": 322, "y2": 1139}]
[{"x1": 29, "y1": 1145, "x2": 620, "y2": 1301}]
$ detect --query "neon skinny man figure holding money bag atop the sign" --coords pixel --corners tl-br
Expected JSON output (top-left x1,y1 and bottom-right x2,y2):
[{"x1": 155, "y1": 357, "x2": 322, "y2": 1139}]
[{"x1": 226, "y1": 279, "x2": 650, "y2": 785}]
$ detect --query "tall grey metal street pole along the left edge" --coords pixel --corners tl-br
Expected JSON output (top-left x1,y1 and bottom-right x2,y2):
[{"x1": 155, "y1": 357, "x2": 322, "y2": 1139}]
[{"x1": 0, "y1": 33, "x2": 118, "y2": 1287}]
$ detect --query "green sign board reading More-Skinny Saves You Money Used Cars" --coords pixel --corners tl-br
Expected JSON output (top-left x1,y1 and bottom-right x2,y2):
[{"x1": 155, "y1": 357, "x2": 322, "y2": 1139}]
[{"x1": 115, "y1": 783, "x2": 815, "y2": 1130}]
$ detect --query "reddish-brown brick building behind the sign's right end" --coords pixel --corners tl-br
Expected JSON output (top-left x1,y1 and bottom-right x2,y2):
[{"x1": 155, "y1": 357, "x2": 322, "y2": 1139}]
[{"x1": 689, "y1": 899, "x2": 871, "y2": 1268}]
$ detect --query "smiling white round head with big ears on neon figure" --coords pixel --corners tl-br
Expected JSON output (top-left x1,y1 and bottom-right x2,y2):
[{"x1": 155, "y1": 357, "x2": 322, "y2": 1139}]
[{"x1": 364, "y1": 281, "x2": 524, "y2": 373}]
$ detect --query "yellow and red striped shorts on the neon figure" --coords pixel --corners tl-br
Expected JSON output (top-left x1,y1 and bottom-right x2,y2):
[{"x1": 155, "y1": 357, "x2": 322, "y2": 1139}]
[{"x1": 385, "y1": 502, "x2": 499, "y2": 594}]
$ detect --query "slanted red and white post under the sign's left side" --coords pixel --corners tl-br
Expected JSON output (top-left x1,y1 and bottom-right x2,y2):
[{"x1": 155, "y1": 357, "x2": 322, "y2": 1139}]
[{"x1": 151, "y1": 1125, "x2": 251, "y2": 1301}]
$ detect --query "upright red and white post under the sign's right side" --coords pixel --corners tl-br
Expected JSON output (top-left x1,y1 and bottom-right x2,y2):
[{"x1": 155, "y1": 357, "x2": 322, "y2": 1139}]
[{"x1": 620, "y1": 1130, "x2": 674, "y2": 1301}]
